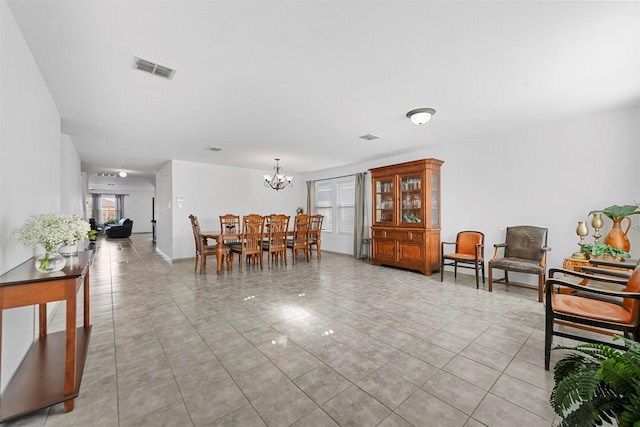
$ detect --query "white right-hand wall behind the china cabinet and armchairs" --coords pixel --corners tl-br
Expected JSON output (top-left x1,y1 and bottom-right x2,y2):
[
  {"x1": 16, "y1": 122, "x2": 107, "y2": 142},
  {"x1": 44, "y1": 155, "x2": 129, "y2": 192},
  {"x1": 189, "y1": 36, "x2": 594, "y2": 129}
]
[{"x1": 302, "y1": 108, "x2": 640, "y2": 281}]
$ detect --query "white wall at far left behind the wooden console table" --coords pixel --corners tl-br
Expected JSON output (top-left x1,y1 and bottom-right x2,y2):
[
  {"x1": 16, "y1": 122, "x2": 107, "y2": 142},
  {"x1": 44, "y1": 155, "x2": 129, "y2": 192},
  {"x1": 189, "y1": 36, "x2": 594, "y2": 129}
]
[{"x1": 0, "y1": 0, "x2": 82, "y2": 389}]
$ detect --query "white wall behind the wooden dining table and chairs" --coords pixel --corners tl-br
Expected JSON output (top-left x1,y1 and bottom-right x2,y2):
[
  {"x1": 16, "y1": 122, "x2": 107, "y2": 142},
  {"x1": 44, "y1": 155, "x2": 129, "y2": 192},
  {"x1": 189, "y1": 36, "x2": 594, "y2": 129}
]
[{"x1": 156, "y1": 160, "x2": 306, "y2": 259}]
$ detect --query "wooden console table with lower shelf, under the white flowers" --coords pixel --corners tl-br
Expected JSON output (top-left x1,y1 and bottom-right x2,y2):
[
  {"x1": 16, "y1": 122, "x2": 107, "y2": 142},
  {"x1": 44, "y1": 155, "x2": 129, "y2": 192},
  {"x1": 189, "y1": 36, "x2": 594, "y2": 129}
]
[{"x1": 0, "y1": 251, "x2": 93, "y2": 422}]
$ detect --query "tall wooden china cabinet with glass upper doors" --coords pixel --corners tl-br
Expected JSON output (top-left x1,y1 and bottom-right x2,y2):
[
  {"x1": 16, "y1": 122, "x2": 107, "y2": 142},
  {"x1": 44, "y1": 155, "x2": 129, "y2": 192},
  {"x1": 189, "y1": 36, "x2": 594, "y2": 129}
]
[{"x1": 371, "y1": 159, "x2": 444, "y2": 275}]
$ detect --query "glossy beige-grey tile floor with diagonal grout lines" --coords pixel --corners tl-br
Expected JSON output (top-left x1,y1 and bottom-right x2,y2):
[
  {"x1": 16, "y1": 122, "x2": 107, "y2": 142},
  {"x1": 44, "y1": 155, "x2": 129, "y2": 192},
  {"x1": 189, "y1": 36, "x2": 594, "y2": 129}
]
[{"x1": 6, "y1": 234, "x2": 576, "y2": 427}]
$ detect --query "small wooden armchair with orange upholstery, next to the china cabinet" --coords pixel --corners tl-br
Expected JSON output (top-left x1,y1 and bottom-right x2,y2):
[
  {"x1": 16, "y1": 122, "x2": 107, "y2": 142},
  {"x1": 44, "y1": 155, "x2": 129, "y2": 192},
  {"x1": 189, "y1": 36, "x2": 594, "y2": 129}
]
[{"x1": 440, "y1": 231, "x2": 485, "y2": 289}]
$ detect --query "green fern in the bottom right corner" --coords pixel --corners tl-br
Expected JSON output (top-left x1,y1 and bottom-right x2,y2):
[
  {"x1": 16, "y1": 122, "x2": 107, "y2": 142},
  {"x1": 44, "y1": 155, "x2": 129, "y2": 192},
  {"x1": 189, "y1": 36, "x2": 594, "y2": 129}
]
[{"x1": 549, "y1": 337, "x2": 640, "y2": 427}]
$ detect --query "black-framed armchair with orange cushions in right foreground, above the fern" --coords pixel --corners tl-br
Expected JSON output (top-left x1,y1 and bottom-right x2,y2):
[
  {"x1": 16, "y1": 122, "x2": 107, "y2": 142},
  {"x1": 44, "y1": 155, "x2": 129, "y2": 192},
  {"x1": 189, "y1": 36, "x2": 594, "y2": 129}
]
[{"x1": 544, "y1": 267, "x2": 640, "y2": 370}]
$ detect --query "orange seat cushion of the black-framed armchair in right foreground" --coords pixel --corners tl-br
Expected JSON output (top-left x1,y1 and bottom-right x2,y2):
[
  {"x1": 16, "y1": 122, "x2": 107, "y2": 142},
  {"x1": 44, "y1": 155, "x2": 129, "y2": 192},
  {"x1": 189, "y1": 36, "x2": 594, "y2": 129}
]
[{"x1": 551, "y1": 294, "x2": 632, "y2": 324}]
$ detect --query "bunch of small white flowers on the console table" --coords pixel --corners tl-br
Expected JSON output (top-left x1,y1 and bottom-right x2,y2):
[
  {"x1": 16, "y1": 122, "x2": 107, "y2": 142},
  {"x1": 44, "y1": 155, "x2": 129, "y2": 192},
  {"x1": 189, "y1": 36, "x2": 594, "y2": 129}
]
[{"x1": 14, "y1": 213, "x2": 91, "y2": 252}]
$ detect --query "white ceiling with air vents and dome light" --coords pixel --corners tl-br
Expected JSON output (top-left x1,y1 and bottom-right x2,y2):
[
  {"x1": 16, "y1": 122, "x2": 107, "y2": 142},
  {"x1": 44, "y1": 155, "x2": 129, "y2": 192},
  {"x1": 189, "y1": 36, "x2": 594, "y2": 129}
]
[{"x1": 8, "y1": 0, "x2": 640, "y2": 191}]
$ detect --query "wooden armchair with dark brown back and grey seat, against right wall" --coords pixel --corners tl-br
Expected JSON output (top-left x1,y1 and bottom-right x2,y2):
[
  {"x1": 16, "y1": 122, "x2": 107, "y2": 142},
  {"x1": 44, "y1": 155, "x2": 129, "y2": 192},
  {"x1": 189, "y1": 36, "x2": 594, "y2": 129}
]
[{"x1": 489, "y1": 225, "x2": 551, "y2": 302}]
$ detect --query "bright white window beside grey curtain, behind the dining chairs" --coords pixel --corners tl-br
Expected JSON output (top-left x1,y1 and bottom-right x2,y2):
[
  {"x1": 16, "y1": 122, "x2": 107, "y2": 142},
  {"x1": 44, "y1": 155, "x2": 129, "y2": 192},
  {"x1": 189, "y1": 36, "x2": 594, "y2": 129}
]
[{"x1": 314, "y1": 177, "x2": 356, "y2": 234}]
